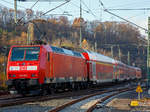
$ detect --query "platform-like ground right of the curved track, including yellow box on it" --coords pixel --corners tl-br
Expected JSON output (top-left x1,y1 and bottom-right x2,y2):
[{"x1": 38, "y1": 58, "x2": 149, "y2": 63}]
[{"x1": 93, "y1": 85, "x2": 150, "y2": 112}]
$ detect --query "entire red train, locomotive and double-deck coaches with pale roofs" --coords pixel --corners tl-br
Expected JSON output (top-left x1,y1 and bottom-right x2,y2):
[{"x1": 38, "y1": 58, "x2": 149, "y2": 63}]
[{"x1": 7, "y1": 45, "x2": 141, "y2": 94}]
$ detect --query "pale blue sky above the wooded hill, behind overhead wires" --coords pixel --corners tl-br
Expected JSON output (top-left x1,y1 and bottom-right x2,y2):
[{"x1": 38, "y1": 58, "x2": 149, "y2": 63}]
[{"x1": 0, "y1": 0, "x2": 150, "y2": 34}]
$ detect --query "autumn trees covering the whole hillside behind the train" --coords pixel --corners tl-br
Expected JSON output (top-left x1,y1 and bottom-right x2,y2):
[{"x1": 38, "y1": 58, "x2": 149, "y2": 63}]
[{"x1": 0, "y1": 7, "x2": 146, "y2": 77}]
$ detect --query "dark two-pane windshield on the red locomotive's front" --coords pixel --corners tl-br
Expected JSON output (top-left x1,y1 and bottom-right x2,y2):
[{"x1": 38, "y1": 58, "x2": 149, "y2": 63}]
[{"x1": 11, "y1": 47, "x2": 40, "y2": 61}]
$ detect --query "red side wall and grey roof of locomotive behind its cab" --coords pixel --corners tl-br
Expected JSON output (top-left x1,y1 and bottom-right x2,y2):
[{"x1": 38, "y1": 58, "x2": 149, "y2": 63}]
[{"x1": 51, "y1": 47, "x2": 87, "y2": 82}]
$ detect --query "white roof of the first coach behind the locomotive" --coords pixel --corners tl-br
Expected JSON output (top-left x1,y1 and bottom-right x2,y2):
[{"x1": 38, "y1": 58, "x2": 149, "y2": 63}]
[{"x1": 85, "y1": 50, "x2": 116, "y2": 63}]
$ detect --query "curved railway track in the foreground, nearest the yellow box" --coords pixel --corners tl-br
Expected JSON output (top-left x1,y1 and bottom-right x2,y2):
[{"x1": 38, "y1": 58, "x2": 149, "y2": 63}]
[{"x1": 48, "y1": 88, "x2": 135, "y2": 112}]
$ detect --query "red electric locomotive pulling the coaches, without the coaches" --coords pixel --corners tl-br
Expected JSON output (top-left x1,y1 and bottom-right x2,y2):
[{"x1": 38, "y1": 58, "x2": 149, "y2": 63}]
[{"x1": 7, "y1": 45, "x2": 87, "y2": 94}]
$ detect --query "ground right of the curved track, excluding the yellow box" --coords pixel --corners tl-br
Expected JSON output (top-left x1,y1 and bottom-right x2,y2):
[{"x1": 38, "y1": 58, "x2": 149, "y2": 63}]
[{"x1": 93, "y1": 90, "x2": 150, "y2": 112}]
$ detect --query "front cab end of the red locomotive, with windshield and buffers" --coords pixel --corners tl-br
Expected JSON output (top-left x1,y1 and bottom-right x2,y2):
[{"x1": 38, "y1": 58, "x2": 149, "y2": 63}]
[{"x1": 7, "y1": 46, "x2": 46, "y2": 94}]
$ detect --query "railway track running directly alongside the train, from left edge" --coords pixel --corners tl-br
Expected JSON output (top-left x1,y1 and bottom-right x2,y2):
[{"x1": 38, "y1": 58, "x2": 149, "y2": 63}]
[{"x1": 0, "y1": 85, "x2": 110, "y2": 107}]
